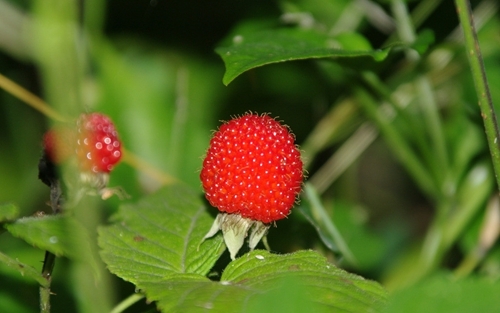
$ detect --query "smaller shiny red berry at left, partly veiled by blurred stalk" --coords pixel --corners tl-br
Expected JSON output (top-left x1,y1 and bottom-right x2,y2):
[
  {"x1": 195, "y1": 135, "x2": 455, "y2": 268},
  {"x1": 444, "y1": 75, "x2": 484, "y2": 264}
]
[{"x1": 76, "y1": 113, "x2": 122, "y2": 173}]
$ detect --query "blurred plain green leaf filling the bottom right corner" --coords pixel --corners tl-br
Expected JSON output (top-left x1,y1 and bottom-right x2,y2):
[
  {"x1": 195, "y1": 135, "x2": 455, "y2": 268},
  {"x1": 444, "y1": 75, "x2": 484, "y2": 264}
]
[{"x1": 384, "y1": 275, "x2": 500, "y2": 313}]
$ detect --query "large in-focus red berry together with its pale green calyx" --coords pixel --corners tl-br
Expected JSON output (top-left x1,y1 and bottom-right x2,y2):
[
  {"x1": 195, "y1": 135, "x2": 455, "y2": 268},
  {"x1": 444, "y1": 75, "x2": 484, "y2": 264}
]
[{"x1": 200, "y1": 113, "x2": 303, "y2": 259}]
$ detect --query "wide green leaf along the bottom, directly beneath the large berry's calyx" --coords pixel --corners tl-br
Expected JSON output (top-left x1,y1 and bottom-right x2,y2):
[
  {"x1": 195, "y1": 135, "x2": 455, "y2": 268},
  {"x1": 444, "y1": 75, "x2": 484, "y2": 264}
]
[{"x1": 138, "y1": 250, "x2": 386, "y2": 313}]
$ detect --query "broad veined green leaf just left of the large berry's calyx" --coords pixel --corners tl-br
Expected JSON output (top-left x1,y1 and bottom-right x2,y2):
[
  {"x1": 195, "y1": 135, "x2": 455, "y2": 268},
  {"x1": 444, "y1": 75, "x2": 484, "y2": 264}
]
[{"x1": 99, "y1": 185, "x2": 223, "y2": 284}]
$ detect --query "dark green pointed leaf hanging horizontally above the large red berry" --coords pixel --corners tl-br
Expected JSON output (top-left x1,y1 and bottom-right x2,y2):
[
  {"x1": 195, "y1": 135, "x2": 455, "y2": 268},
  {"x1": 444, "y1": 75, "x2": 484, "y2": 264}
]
[{"x1": 215, "y1": 28, "x2": 389, "y2": 85}]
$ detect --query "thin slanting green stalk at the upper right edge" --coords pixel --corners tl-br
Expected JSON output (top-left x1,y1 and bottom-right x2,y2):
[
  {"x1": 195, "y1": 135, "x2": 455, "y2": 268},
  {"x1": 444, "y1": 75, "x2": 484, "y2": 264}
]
[{"x1": 455, "y1": 0, "x2": 500, "y2": 188}]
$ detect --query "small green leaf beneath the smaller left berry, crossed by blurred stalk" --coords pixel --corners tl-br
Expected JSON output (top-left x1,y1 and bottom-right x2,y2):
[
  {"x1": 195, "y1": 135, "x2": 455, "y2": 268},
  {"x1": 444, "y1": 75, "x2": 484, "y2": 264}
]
[{"x1": 5, "y1": 215, "x2": 90, "y2": 260}]
